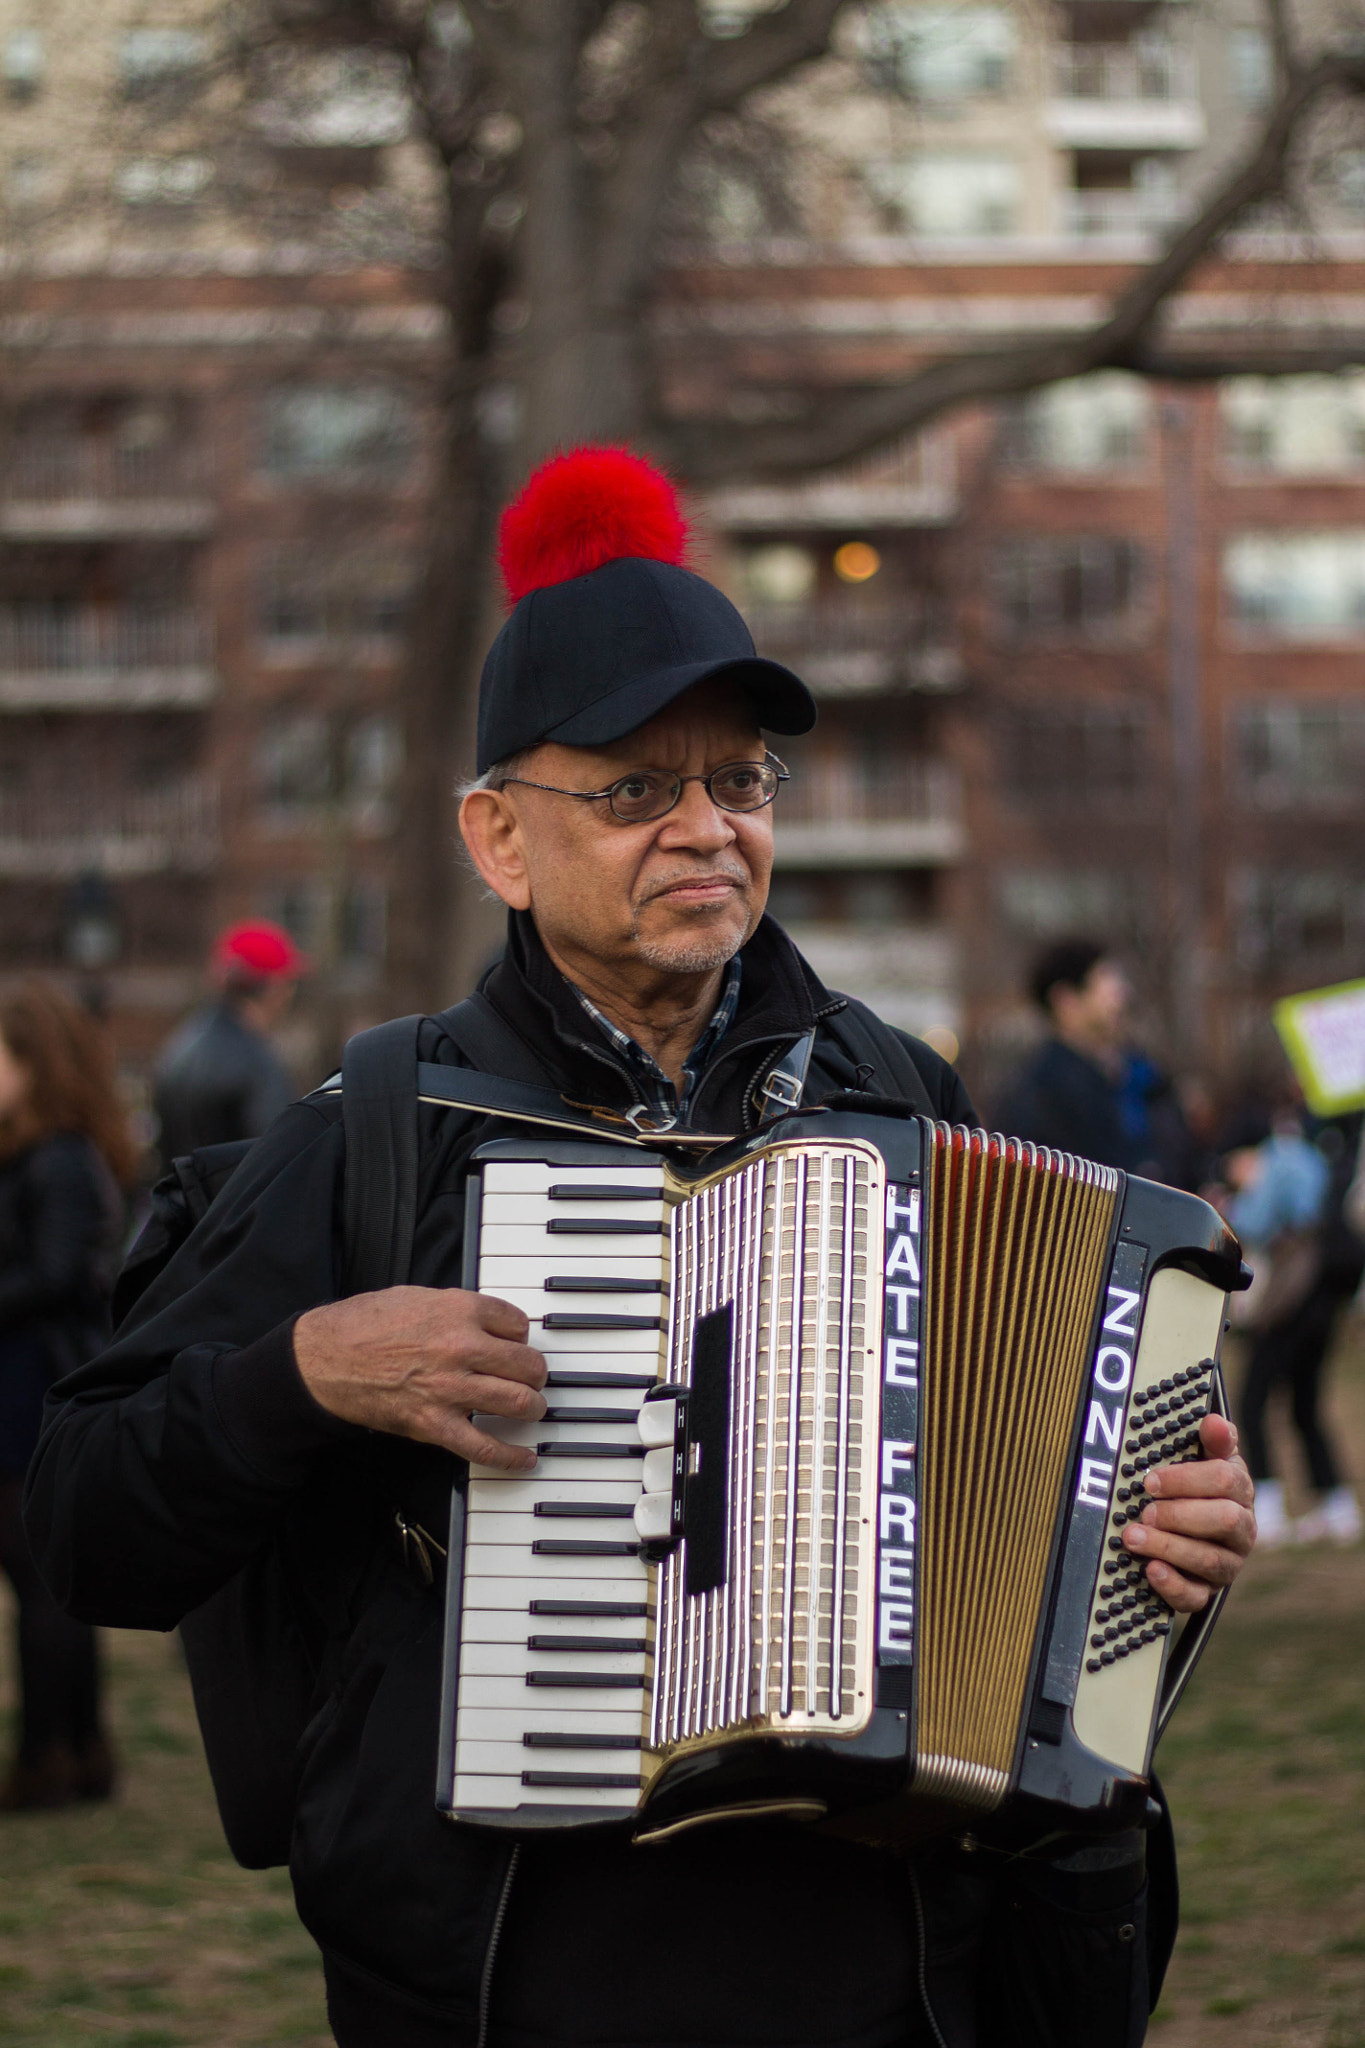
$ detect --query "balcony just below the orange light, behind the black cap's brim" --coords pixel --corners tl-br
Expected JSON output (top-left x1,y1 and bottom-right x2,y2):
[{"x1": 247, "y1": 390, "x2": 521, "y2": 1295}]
[{"x1": 745, "y1": 596, "x2": 962, "y2": 696}]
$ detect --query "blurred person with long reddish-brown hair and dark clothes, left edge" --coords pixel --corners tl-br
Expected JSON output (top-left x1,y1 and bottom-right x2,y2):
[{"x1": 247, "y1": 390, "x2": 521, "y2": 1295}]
[{"x1": 0, "y1": 979, "x2": 137, "y2": 1812}]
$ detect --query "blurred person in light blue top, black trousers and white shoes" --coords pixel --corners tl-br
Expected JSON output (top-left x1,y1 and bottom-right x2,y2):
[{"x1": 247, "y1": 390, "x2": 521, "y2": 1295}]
[{"x1": 1205, "y1": 1085, "x2": 1365, "y2": 1548}]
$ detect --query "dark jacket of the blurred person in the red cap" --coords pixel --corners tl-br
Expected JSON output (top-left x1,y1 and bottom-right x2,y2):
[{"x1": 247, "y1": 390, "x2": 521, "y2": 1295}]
[{"x1": 151, "y1": 997, "x2": 295, "y2": 1165}]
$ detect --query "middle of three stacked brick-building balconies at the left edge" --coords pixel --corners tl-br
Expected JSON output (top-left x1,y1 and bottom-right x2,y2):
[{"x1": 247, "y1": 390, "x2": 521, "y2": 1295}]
[{"x1": 0, "y1": 600, "x2": 217, "y2": 713}]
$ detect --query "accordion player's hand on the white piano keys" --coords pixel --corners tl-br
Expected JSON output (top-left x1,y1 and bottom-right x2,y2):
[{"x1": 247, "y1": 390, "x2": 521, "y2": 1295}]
[{"x1": 295, "y1": 1286, "x2": 544, "y2": 1473}]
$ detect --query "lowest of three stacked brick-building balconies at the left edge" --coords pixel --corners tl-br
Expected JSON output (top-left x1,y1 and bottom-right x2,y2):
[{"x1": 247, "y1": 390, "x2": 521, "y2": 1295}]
[{"x1": 0, "y1": 776, "x2": 219, "y2": 881}]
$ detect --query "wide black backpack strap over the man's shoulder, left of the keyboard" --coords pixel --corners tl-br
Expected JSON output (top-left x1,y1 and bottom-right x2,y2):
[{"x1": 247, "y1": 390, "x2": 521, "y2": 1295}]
[{"x1": 342, "y1": 1016, "x2": 426, "y2": 1294}]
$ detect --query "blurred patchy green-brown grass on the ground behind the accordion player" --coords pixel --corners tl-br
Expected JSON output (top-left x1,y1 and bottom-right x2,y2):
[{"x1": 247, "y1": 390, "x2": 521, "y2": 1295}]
[{"x1": 0, "y1": 1333, "x2": 1365, "y2": 2048}]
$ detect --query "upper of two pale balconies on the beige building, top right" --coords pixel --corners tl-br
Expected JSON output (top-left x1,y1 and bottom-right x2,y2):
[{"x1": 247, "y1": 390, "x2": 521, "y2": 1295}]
[{"x1": 1044, "y1": 41, "x2": 1207, "y2": 152}]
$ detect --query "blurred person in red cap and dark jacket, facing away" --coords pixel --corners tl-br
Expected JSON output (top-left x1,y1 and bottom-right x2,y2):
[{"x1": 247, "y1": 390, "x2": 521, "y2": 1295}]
[{"x1": 151, "y1": 920, "x2": 307, "y2": 1167}]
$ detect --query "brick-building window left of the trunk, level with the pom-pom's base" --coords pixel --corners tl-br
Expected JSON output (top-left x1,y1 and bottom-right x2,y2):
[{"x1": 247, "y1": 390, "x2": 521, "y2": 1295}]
[{"x1": 258, "y1": 541, "x2": 411, "y2": 662}]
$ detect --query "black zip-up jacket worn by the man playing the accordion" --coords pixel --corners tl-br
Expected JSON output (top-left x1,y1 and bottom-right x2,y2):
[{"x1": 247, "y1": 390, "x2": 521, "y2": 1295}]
[{"x1": 29, "y1": 918, "x2": 1170, "y2": 2048}]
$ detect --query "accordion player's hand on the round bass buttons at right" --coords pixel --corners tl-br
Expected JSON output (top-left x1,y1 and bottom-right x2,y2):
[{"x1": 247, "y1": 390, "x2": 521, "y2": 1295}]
[{"x1": 1124, "y1": 1415, "x2": 1257, "y2": 1614}]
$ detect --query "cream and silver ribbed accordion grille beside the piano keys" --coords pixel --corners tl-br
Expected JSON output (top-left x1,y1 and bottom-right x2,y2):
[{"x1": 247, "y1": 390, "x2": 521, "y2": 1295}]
[{"x1": 649, "y1": 1145, "x2": 884, "y2": 1749}]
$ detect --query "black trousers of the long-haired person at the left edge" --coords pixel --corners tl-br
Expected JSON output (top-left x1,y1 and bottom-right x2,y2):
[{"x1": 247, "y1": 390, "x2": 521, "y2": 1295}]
[{"x1": 0, "y1": 1473, "x2": 100, "y2": 1763}]
